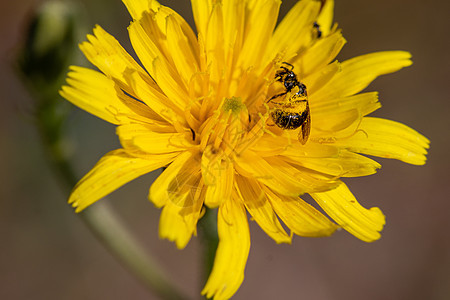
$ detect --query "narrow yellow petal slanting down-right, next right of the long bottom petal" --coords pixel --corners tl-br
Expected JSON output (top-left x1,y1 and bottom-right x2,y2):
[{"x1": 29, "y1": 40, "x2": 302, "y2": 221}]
[{"x1": 236, "y1": 176, "x2": 291, "y2": 244}]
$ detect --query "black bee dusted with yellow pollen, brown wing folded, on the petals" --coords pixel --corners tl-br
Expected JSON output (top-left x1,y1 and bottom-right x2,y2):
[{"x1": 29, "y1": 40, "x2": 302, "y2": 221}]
[{"x1": 267, "y1": 62, "x2": 311, "y2": 145}]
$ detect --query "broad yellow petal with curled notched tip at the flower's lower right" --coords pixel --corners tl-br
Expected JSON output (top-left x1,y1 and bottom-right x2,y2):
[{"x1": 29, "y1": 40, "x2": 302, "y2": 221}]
[{"x1": 311, "y1": 183, "x2": 385, "y2": 242}]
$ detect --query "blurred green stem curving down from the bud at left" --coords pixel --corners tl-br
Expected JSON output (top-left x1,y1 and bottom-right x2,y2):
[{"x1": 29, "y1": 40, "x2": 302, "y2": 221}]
[{"x1": 37, "y1": 107, "x2": 188, "y2": 300}]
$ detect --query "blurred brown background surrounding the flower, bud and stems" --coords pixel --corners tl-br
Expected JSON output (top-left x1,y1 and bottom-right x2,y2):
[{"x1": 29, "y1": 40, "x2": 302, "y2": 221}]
[{"x1": 0, "y1": 0, "x2": 450, "y2": 300}]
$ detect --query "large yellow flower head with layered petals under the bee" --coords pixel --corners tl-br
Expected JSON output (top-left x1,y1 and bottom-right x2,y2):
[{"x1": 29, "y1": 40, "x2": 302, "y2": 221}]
[{"x1": 61, "y1": 0, "x2": 429, "y2": 299}]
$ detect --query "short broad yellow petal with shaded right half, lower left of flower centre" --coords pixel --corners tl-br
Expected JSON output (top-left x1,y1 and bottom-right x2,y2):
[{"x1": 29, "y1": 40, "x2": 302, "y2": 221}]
[{"x1": 149, "y1": 151, "x2": 201, "y2": 208}]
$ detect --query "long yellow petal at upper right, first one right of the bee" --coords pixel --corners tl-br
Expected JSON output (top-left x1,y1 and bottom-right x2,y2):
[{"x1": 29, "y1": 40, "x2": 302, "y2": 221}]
[{"x1": 314, "y1": 51, "x2": 412, "y2": 102}]
